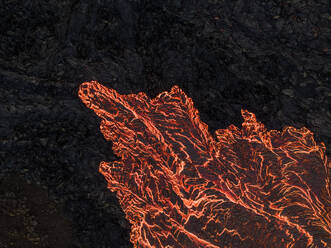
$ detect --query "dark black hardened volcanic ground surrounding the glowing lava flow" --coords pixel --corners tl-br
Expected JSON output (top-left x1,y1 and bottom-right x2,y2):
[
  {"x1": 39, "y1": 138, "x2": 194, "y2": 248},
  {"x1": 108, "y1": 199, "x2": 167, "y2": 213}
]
[{"x1": 0, "y1": 0, "x2": 331, "y2": 248}]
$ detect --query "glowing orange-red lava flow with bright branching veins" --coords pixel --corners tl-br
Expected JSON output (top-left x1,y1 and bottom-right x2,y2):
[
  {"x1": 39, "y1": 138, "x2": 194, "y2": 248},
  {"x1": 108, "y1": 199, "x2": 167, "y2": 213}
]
[{"x1": 79, "y1": 81, "x2": 331, "y2": 248}]
